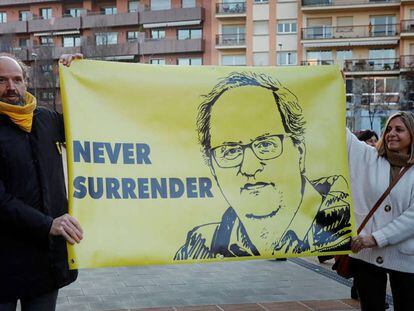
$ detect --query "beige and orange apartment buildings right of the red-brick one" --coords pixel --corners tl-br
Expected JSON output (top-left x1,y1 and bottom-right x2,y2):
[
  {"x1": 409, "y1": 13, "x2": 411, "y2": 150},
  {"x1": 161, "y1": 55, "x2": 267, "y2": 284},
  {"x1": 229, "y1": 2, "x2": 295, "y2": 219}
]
[{"x1": 211, "y1": 0, "x2": 414, "y2": 131}]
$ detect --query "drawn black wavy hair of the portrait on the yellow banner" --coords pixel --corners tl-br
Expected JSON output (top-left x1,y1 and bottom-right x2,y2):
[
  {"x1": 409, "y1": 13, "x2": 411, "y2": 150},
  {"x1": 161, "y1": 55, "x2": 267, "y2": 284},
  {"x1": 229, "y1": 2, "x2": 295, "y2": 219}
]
[{"x1": 197, "y1": 72, "x2": 306, "y2": 165}]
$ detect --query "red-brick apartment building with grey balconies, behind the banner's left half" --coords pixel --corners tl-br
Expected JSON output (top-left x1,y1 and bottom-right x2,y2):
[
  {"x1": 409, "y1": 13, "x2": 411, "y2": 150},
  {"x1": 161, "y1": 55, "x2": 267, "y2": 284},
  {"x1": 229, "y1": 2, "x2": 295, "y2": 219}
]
[{"x1": 0, "y1": 0, "x2": 208, "y2": 108}]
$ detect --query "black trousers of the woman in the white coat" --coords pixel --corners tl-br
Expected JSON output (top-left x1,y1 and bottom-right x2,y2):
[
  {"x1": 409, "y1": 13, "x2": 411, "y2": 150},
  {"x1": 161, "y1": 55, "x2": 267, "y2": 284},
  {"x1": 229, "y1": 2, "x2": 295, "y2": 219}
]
[{"x1": 351, "y1": 258, "x2": 414, "y2": 311}]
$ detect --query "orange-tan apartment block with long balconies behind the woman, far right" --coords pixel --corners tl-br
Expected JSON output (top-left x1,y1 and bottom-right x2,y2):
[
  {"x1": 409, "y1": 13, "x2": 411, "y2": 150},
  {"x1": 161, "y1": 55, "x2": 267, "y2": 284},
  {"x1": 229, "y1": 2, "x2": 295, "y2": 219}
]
[{"x1": 299, "y1": 0, "x2": 414, "y2": 131}]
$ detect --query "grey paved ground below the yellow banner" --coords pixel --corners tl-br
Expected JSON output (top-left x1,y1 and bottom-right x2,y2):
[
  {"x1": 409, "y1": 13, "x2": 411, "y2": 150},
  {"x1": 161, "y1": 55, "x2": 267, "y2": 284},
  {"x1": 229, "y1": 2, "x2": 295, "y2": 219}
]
[{"x1": 47, "y1": 259, "x2": 382, "y2": 311}]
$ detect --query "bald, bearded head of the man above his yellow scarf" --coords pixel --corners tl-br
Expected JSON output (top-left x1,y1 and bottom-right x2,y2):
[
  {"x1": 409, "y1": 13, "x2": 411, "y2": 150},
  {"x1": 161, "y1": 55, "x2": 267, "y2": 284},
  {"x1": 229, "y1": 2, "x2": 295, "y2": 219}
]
[{"x1": 0, "y1": 57, "x2": 26, "y2": 105}]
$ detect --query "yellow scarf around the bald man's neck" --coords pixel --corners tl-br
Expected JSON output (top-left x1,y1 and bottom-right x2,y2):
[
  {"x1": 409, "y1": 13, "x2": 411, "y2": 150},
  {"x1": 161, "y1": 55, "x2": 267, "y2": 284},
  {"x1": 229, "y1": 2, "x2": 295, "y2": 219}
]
[{"x1": 0, "y1": 92, "x2": 36, "y2": 133}]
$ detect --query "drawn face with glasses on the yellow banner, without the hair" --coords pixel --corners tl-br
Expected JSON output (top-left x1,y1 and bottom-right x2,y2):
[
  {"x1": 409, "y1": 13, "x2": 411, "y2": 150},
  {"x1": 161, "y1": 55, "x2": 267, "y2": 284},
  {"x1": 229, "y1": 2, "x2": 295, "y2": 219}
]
[{"x1": 210, "y1": 86, "x2": 303, "y2": 222}]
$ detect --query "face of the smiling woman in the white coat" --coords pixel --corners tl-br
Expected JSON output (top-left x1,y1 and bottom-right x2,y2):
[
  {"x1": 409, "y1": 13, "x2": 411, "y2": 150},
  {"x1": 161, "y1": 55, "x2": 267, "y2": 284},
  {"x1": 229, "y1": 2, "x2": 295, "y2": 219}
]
[{"x1": 385, "y1": 117, "x2": 411, "y2": 154}]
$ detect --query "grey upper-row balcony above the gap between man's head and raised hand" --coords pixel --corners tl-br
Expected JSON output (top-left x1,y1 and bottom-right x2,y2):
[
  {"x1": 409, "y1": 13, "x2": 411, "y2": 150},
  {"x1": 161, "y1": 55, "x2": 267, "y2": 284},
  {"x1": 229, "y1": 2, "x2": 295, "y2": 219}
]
[{"x1": 27, "y1": 17, "x2": 81, "y2": 32}]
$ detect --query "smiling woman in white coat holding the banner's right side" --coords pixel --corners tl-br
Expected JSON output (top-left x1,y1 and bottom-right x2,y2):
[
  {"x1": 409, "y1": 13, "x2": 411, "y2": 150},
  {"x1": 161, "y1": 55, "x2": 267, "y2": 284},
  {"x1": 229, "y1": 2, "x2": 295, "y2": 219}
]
[{"x1": 347, "y1": 112, "x2": 414, "y2": 311}]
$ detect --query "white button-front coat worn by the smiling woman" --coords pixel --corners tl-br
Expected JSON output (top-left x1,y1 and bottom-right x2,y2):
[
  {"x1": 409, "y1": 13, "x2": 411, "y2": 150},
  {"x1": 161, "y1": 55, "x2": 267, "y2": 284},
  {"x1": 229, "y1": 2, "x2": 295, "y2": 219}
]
[{"x1": 347, "y1": 130, "x2": 414, "y2": 273}]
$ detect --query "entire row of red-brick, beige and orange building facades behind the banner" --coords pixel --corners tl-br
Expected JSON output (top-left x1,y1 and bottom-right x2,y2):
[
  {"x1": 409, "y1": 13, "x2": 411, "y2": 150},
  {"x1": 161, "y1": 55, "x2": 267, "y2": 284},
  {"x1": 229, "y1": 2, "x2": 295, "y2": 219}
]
[{"x1": 0, "y1": 0, "x2": 414, "y2": 131}]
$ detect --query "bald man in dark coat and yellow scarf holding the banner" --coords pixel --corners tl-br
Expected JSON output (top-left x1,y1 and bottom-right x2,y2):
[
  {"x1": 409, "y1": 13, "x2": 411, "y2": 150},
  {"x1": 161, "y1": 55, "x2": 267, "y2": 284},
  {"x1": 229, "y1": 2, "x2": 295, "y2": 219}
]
[{"x1": 0, "y1": 54, "x2": 83, "y2": 311}]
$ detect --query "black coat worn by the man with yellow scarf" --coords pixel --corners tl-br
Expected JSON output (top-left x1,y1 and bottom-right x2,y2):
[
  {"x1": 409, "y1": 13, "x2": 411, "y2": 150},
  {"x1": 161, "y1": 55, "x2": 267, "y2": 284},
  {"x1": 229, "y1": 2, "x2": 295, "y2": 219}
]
[{"x1": 0, "y1": 108, "x2": 77, "y2": 302}]
